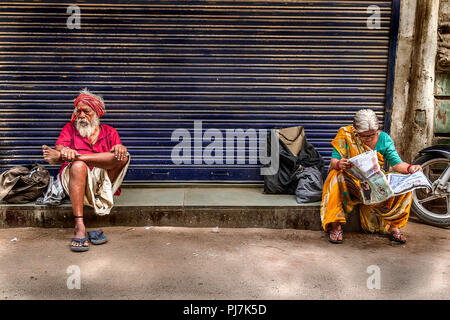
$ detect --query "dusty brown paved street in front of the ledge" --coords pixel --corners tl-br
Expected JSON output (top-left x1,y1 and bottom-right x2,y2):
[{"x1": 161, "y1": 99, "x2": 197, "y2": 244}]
[{"x1": 0, "y1": 221, "x2": 450, "y2": 300}]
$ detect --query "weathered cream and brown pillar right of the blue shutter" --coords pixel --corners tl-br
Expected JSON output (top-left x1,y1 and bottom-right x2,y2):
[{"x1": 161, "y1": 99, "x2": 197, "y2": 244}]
[{"x1": 391, "y1": 0, "x2": 439, "y2": 162}]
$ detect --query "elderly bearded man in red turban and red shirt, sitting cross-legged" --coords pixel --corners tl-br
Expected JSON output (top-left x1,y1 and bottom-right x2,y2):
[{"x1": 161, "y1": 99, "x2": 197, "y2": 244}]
[{"x1": 42, "y1": 89, "x2": 130, "y2": 251}]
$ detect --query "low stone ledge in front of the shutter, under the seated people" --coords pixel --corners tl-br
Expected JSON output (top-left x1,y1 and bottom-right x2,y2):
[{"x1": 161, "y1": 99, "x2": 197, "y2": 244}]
[{"x1": 0, "y1": 188, "x2": 360, "y2": 231}]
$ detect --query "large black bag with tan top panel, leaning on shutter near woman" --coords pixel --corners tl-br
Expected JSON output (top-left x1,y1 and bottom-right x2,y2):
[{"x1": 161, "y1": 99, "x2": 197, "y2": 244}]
[{"x1": 264, "y1": 126, "x2": 324, "y2": 194}]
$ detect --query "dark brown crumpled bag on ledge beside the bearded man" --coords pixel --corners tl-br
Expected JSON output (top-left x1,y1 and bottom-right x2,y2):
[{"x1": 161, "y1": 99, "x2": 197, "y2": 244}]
[{"x1": 0, "y1": 163, "x2": 50, "y2": 203}]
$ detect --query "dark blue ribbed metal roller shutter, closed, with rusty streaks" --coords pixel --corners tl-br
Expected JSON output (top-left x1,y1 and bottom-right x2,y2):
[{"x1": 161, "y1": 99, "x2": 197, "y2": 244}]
[{"x1": 0, "y1": 0, "x2": 398, "y2": 182}]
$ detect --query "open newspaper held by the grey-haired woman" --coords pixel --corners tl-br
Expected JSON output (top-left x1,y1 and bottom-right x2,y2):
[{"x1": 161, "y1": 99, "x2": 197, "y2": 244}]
[{"x1": 348, "y1": 150, "x2": 431, "y2": 204}]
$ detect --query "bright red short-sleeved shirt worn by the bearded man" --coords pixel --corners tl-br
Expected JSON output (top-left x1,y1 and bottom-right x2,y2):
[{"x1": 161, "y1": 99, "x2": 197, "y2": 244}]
[{"x1": 55, "y1": 122, "x2": 122, "y2": 194}]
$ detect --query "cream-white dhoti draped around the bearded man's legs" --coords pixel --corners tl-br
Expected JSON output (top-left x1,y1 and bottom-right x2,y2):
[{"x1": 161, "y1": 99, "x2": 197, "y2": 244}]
[{"x1": 60, "y1": 153, "x2": 131, "y2": 216}]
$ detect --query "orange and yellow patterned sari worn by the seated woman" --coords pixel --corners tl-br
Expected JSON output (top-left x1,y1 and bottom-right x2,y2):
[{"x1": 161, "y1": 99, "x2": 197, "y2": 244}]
[{"x1": 320, "y1": 126, "x2": 412, "y2": 233}]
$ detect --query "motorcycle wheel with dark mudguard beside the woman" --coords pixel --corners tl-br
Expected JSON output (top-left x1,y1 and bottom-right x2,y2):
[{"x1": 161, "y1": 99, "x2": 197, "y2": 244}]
[{"x1": 411, "y1": 154, "x2": 450, "y2": 227}]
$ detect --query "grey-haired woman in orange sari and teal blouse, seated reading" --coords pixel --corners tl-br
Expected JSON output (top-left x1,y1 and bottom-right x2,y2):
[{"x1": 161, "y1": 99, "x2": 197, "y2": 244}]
[{"x1": 320, "y1": 109, "x2": 422, "y2": 243}]
